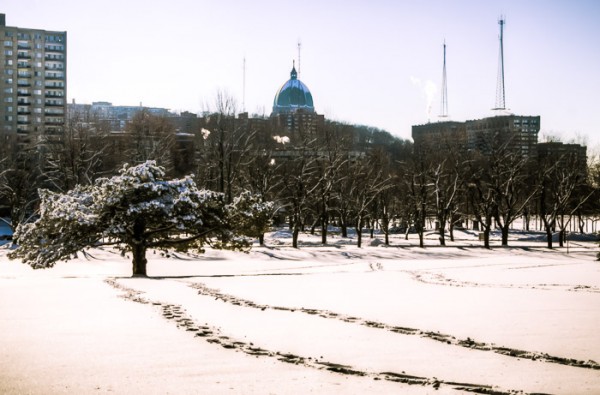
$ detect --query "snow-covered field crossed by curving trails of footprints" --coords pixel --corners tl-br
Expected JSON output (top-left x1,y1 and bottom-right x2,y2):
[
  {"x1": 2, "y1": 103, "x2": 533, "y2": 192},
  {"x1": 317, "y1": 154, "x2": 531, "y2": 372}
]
[{"x1": 0, "y1": 231, "x2": 600, "y2": 394}]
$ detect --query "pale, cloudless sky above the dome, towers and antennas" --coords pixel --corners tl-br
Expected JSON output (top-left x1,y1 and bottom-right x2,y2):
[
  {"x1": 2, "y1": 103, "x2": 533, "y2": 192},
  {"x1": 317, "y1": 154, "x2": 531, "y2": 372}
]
[{"x1": 0, "y1": 0, "x2": 600, "y2": 148}]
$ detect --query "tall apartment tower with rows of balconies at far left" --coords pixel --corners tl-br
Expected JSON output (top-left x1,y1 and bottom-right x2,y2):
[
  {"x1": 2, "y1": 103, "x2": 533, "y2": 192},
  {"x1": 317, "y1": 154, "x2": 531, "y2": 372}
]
[{"x1": 0, "y1": 14, "x2": 67, "y2": 152}]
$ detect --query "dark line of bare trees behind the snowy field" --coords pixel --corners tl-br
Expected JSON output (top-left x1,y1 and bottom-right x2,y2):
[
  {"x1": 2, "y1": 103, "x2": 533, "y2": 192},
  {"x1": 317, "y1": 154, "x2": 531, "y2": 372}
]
[{"x1": 0, "y1": 106, "x2": 600, "y2": 248}]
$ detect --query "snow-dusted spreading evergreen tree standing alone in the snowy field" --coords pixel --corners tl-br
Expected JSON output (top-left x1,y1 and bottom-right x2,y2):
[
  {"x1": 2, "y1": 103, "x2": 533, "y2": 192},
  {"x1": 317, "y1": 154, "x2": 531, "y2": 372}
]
[{"x1": 9, "y1": 161, "x2": 272, "y2": 276}]
